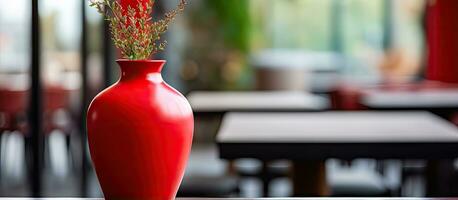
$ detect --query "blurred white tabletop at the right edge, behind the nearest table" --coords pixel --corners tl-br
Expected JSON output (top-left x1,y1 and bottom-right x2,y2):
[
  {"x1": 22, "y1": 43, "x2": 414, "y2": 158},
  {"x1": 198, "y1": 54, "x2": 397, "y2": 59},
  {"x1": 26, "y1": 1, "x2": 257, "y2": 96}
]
[{"x1": 362, "y1": 88, "x2": 458, "y2": 108}]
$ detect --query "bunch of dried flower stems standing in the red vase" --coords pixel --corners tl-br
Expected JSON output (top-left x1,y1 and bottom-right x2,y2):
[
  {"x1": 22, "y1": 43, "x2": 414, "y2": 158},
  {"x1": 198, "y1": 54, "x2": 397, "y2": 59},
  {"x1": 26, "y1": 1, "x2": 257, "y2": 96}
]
[{"x1": 90, "y1": 0, "x2": 186, "y2": 60}]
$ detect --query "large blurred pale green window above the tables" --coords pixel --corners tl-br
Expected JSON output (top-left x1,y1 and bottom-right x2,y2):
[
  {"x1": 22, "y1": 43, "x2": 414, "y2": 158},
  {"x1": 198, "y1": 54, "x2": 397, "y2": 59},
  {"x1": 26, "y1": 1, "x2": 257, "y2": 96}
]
[{"x1": 251, "y1": 0, "x2": 424, "y2": 79}]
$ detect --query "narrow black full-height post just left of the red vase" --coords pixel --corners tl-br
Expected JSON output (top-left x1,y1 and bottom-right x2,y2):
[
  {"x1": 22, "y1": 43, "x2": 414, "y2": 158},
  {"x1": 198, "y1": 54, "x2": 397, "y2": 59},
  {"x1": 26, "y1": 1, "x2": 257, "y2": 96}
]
[{"x1": 80, "y1": 0, "x2": 89, "y2": 197}]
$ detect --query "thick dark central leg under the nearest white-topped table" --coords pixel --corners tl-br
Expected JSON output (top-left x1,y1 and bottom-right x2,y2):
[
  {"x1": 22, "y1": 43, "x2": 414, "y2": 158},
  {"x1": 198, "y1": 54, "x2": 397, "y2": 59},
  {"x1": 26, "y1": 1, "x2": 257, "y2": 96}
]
[{"x1": 292, "y1": 161, "x2": 330, "y2": 197}]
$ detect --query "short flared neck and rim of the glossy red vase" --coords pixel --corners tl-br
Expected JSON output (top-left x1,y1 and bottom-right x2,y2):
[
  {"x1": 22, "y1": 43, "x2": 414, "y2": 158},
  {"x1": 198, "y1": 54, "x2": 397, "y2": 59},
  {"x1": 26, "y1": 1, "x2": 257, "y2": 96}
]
[{"x1": 116, "y1": 60, "x2": 166, "y2": 81}]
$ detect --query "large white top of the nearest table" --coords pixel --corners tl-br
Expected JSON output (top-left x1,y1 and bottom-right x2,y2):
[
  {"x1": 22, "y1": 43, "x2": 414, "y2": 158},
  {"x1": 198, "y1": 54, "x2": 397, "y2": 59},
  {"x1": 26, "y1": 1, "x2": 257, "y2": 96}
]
[{"x1": 217, "y1": 112, "x2": 458, "y2": 143}]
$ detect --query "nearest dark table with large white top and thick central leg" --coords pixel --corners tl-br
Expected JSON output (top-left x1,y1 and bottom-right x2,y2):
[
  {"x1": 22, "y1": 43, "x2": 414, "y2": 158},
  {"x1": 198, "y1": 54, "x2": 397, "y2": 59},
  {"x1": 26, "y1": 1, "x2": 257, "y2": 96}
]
[{"x1": 217, "y1": 112, "x2": 458, "y2": 196}]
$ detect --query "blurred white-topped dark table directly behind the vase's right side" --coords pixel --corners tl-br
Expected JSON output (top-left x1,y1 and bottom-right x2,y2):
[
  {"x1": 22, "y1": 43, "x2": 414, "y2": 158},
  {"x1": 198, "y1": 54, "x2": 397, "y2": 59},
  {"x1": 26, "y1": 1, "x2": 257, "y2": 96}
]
[{"x1": 187, "y1": 91, "x2": 330, "y2": 196}]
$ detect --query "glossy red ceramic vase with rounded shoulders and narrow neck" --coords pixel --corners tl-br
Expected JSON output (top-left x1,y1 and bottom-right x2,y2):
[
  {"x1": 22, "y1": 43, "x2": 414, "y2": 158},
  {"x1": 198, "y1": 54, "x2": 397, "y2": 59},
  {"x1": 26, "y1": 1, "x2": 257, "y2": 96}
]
[{"x1": 87, "y1": 60, "x2": 194, "y2": 200}]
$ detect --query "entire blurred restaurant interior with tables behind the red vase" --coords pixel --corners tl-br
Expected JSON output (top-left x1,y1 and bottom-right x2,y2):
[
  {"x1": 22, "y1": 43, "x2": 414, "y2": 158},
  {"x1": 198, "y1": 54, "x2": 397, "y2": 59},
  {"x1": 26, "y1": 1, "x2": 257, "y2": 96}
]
[{"x1": 0, "y1": 0, "x2": 458, "y2": 198}]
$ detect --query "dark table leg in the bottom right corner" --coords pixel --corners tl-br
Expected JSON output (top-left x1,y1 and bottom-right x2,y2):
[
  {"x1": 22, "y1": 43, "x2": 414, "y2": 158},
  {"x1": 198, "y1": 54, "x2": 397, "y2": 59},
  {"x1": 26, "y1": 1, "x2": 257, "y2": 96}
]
[{"x1": 426, "y1": 160, "x2": 454, "y2": 197}]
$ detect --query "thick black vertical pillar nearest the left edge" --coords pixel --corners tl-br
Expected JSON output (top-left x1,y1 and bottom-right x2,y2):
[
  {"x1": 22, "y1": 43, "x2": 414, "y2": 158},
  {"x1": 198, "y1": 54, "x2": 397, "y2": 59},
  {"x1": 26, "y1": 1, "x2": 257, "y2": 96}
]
[{"x1": 27, "y1": 0, "x2": 44, "y2": 197}]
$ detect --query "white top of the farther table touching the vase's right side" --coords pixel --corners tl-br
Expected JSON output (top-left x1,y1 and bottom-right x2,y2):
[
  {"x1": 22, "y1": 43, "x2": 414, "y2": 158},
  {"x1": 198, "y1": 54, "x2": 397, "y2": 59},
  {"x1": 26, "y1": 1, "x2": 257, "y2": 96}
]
[{"x1": 187, "y1": 91, "x2": 329, "y2": 112}]
